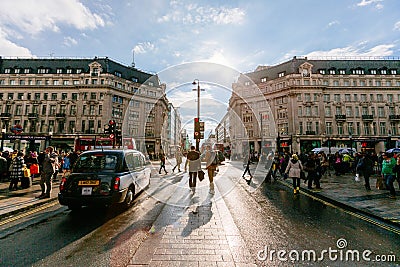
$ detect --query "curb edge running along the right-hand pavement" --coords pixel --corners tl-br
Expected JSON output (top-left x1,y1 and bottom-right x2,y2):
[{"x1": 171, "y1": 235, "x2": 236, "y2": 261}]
[{"x1": 277, "y1": 180, "x2": 400, "y2": 228}]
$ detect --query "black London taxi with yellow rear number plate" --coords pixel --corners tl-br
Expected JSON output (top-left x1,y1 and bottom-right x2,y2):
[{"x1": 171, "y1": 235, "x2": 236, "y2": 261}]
[{"x1": 58, "y1": 150, "x2": 151, "y2": 210}]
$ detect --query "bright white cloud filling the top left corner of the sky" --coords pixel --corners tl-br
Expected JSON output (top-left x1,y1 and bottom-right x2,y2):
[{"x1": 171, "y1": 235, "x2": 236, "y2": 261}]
[{"x1": 0, "y1": 0, "x2": 105, "y2": 35}]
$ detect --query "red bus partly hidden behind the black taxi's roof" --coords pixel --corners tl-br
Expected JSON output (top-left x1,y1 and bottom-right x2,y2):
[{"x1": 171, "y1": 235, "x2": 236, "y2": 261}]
[{"x1": 74, "y1": 137, "x2": 136, "y2": 151}]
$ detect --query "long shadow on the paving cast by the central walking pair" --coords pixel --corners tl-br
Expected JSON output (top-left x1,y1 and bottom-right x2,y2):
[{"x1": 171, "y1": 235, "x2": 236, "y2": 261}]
[{"x1": 181, "y1": 193, "x2": 214, "y2": 237}]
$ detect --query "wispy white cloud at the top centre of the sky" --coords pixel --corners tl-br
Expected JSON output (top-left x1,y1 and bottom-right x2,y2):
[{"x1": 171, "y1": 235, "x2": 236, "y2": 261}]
[{"x1": 158, "y1": 1, "x2": 245, "y2": 25}]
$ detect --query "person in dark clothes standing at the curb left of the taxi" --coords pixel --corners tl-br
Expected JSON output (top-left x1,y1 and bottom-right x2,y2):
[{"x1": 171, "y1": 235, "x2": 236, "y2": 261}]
[{"x1": 37, "y1": 146, "x2": 58, "y2": 199}]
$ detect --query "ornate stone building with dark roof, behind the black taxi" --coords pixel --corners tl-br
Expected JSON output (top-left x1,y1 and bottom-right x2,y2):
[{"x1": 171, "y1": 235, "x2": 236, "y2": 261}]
[{"x1": 0, "y1": 57, "x2": 169, "y2": 156}]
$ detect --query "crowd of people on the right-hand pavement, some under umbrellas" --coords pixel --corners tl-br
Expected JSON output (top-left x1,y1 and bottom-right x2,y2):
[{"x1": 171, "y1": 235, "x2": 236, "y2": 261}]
[{"x1": 256, "y1": 152, "x2": 400, "y2": 199}]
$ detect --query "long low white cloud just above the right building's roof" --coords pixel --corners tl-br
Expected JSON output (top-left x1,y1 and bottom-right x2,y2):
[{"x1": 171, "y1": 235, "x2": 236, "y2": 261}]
[{"x1": 306, "y1": 43, "x2": 395, "y2": 58}]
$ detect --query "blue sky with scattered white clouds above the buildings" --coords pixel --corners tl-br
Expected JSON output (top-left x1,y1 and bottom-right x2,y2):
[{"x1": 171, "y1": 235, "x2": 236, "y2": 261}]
[{"x1": 0, "y1": 0, "x2": 400, "y2": 144}]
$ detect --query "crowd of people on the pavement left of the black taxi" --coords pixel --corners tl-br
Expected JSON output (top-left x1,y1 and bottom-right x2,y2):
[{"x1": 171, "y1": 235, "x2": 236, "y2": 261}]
[{"x1": 0, "y1": 146, "x2": 79, "y2": 198}]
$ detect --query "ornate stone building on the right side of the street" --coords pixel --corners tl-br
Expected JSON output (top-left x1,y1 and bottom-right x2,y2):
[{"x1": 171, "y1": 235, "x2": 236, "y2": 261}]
[{"x1": 230, "y1": 57, "x2": 400, "y2": 157}]
